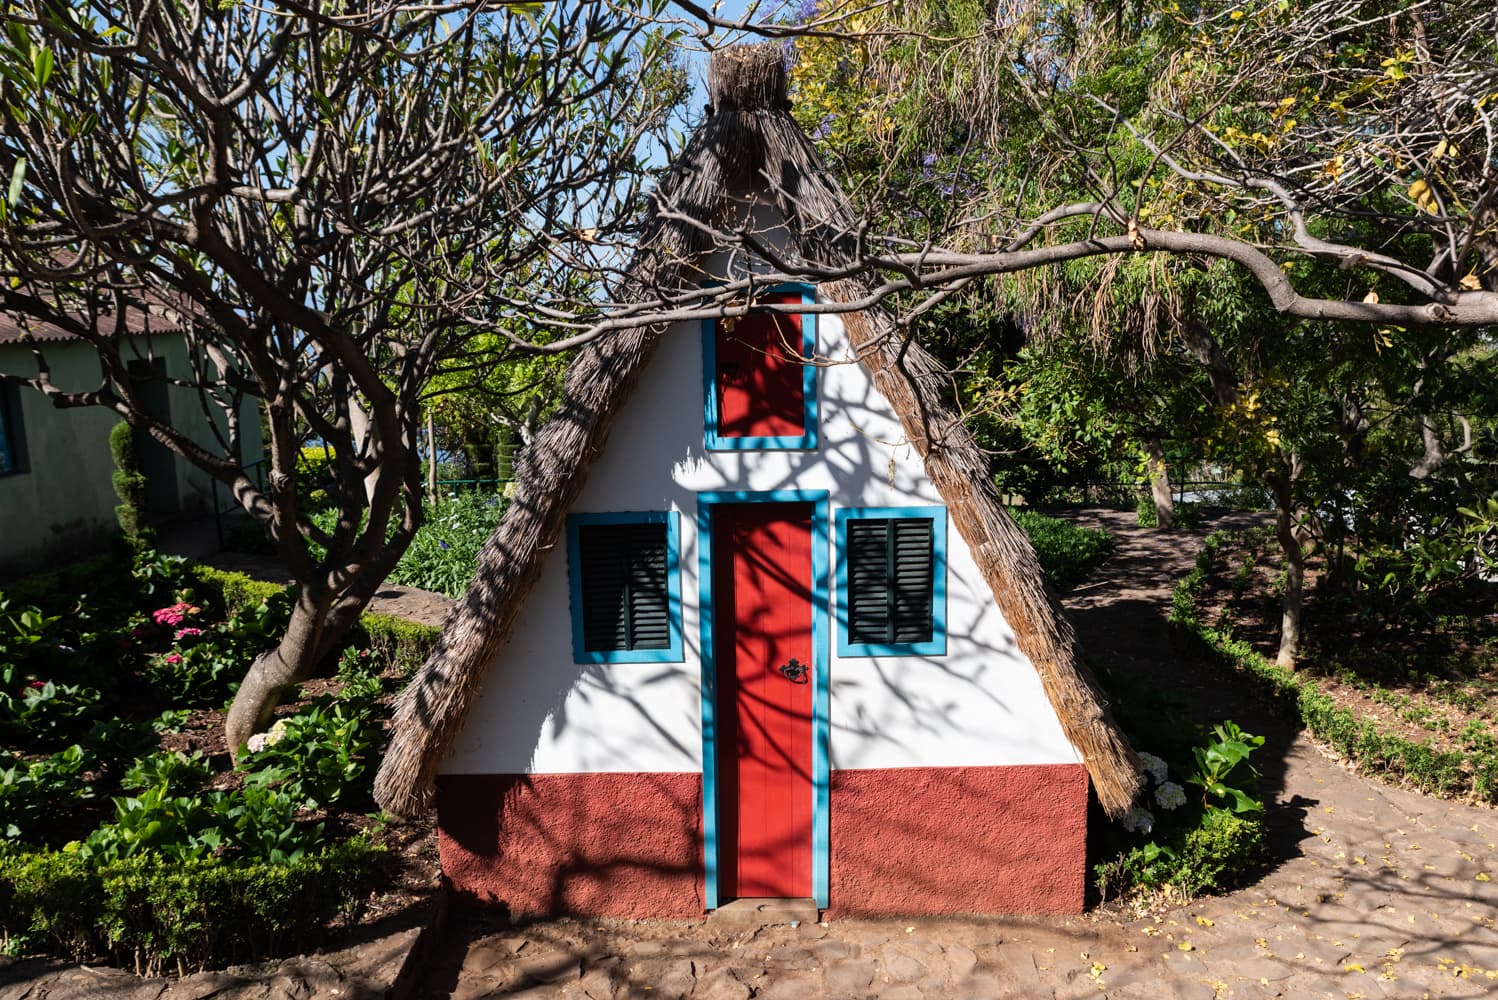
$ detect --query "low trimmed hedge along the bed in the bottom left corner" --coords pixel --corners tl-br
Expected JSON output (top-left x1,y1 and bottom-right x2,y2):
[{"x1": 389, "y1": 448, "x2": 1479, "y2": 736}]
[{"x1": 0, "y1": 837, "x2": 383, "y2": 973}]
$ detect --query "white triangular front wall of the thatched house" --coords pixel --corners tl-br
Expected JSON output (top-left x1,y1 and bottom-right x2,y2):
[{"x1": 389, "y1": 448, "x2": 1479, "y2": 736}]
[{"x1": 442, "y1": 308, "x2": 1080, "y2": 774}]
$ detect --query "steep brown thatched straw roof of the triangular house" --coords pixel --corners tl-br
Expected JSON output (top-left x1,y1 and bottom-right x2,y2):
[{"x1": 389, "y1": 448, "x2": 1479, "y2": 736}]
[{"x1": 375, "y1": 45, "x2": 1140, "y2": 817}]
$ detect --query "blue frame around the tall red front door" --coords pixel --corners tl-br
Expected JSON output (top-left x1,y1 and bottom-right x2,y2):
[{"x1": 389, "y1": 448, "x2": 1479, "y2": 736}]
[{"x1": 697, "y1": 490, "x2": 831, "y2": 910}]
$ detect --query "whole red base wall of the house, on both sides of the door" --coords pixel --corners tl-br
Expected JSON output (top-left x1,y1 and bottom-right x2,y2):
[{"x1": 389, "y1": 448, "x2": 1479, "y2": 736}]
[{"x1": 437, "y1": 765, "x2": 1088, "y2": 918}]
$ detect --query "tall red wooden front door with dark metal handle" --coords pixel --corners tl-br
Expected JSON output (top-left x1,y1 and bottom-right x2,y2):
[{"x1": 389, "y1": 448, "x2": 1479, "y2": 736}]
[{"x1": 713, "y1": 503, "x2": 816, "y2": 900}]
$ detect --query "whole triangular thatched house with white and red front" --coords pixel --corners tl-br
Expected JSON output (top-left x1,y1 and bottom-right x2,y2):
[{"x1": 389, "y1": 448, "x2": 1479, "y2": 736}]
[{"x1": 376, "y1": 45, "x2": 1138, "y2": 916}]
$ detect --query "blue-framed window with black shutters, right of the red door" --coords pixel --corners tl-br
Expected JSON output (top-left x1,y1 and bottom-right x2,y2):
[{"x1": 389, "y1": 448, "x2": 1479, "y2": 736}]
[{"x1": 836, "y1": 507, "x2": 947, "y2": 656}]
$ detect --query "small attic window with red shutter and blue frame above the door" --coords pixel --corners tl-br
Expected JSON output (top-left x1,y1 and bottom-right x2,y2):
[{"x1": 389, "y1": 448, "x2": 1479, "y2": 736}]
[{"x1": 703, "y1": 284, "x2": 816, "y2": 451}]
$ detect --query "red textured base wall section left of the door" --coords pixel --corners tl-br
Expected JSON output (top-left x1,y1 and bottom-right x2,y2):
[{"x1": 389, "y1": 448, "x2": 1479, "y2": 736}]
[{"x1": 437, "y1": 774, "x2": 704, "y2": 918}]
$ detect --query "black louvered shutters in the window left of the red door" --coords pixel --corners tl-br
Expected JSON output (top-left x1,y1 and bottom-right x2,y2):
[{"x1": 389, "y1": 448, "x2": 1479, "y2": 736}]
[{"x1": 578, "y1": 524, "x2": 671, "y2": 651}]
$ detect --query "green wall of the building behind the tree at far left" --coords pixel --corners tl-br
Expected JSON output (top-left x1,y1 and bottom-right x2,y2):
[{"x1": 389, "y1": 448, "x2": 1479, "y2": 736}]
[{"x1": 0, "y1": 335, "x2": 262, "y2": 576}]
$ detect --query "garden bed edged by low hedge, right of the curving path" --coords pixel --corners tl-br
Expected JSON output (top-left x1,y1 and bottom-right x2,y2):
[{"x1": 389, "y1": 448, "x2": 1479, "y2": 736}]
[{"x1": 1174, "y1": 533, "x2": 1498, "y2": 804}]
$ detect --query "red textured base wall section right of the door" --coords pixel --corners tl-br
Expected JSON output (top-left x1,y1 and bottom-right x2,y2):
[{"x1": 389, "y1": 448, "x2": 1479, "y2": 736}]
[{"x1": 828, "y1": 763, "x2": 1088, "y2": 916}]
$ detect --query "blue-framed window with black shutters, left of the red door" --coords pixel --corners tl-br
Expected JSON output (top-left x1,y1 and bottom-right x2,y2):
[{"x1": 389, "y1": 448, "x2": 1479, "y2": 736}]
[{"x1": 566, "y1": 510, "x2": 683, "y2": 663}]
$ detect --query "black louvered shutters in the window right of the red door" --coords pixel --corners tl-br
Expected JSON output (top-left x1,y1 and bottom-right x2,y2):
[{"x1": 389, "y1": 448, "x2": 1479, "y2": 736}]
[{"x1": 843, "y1": 518, "x2": 935, "y2": 644}]
